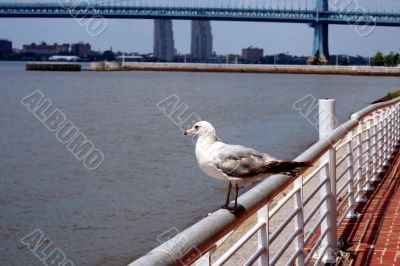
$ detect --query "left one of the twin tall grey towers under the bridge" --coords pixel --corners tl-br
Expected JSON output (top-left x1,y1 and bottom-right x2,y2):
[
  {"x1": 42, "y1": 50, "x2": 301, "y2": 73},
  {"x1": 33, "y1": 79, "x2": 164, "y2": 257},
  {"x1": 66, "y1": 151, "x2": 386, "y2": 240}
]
[{"x1": 153, "y1": 19, "x2": 175, "y2": 61}]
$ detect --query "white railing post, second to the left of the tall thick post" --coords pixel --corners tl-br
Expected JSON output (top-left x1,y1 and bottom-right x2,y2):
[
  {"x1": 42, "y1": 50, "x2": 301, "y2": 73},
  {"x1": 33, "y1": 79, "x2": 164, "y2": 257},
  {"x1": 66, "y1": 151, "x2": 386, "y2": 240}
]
[{"x1": 257, "y1": 204, "x2": 269, "y2": 266}]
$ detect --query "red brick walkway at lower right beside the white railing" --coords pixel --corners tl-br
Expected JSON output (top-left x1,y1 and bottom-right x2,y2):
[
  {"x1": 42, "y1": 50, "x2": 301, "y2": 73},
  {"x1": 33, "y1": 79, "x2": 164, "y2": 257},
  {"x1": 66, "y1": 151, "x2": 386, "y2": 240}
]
[{"x1": 338, "y1": 147, "x2": 400, "y2": 265}]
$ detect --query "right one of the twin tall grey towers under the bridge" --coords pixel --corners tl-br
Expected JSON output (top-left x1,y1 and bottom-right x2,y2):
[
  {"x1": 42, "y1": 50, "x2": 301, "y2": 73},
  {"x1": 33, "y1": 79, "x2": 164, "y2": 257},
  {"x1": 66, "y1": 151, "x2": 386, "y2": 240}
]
[{"x1": 191, "y1": 20, "x2": 213, "y2": 60}]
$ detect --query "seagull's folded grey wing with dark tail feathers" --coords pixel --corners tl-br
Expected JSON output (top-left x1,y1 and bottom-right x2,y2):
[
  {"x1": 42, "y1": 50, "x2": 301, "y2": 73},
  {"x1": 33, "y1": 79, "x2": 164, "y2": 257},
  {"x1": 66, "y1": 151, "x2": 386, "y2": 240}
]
[{"x1": 216, "y1": 144, "x2": 310, "y2": 178}]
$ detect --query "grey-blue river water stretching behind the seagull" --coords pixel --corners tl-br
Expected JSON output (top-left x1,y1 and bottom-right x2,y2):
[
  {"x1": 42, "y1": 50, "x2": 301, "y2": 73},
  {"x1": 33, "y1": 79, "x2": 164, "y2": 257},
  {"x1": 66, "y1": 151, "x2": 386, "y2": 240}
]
[{"x1": 0, "y1": 62, "x2": 400, "y2": 265}]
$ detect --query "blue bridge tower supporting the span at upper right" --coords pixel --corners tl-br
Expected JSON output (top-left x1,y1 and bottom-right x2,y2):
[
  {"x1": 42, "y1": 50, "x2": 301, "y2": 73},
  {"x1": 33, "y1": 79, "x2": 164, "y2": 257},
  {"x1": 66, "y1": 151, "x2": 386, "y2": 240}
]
[{"x1": 311, "y1": 0, "x2": 329, "y2": 59}]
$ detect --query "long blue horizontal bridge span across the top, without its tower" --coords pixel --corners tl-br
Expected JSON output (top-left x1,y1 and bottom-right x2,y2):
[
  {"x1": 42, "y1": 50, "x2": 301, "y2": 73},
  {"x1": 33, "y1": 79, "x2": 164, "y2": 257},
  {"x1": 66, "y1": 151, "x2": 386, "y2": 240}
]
[{"x1": 0, "y1": 3, "x2": 400, "y2": 26}]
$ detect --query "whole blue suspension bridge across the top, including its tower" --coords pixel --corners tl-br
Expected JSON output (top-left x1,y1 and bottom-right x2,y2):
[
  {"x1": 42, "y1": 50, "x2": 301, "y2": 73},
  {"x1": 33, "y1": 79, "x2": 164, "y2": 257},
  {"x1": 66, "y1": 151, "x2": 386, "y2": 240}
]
[{"x1": 0, "y1": 0, "x2": 400, "y2": 56}]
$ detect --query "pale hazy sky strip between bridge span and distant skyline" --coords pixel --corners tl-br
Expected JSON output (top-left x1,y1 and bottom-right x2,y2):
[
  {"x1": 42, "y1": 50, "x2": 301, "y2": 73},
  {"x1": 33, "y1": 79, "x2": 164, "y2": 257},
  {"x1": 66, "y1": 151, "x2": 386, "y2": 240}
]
[{"x1": 0, "y1": 18, "x2": 400, "y2": 56}]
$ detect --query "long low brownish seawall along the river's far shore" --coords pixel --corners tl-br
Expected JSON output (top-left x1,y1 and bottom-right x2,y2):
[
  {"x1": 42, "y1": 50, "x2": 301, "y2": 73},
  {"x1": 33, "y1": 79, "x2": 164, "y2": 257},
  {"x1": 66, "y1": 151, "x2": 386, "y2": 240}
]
[{"x1": 120, "y1": 63, "x2": 400, "y2": 76}]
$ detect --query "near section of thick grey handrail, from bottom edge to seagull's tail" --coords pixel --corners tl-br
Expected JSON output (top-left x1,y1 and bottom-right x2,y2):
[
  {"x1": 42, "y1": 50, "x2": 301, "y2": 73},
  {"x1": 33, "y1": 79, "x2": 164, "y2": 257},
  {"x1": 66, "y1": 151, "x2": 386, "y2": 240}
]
[{"x1": 130, "y1": 172, "x2": 293, "y2": 266}]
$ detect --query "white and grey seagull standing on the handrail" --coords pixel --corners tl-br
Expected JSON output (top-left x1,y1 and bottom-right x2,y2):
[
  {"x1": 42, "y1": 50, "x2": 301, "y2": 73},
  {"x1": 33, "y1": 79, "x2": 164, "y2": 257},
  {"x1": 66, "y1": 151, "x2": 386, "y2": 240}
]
[{"x1": 184, "y1": 121, "x2": 312, "y2": 211}]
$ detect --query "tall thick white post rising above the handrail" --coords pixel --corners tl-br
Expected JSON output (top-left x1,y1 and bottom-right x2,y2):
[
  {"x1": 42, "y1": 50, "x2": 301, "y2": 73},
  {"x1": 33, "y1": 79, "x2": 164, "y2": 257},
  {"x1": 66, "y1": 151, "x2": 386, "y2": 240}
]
[{"x1": 319, "y1": 99, "x2": 337, "y2": 263}]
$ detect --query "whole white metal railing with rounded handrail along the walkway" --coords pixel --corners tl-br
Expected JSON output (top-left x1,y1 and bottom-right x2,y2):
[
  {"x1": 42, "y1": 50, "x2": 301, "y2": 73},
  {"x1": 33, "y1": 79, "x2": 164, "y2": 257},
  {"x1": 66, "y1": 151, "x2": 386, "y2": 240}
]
[{"x1": 130, "y1": 98, "x2": 400, "y2": 266}]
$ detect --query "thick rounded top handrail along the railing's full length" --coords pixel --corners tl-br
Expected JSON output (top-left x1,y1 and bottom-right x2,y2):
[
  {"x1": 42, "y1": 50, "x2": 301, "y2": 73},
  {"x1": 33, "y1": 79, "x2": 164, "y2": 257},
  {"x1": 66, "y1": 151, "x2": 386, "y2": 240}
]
[{"x1": 130, "y1": 95, "x2": 400, "y2": 266}]
